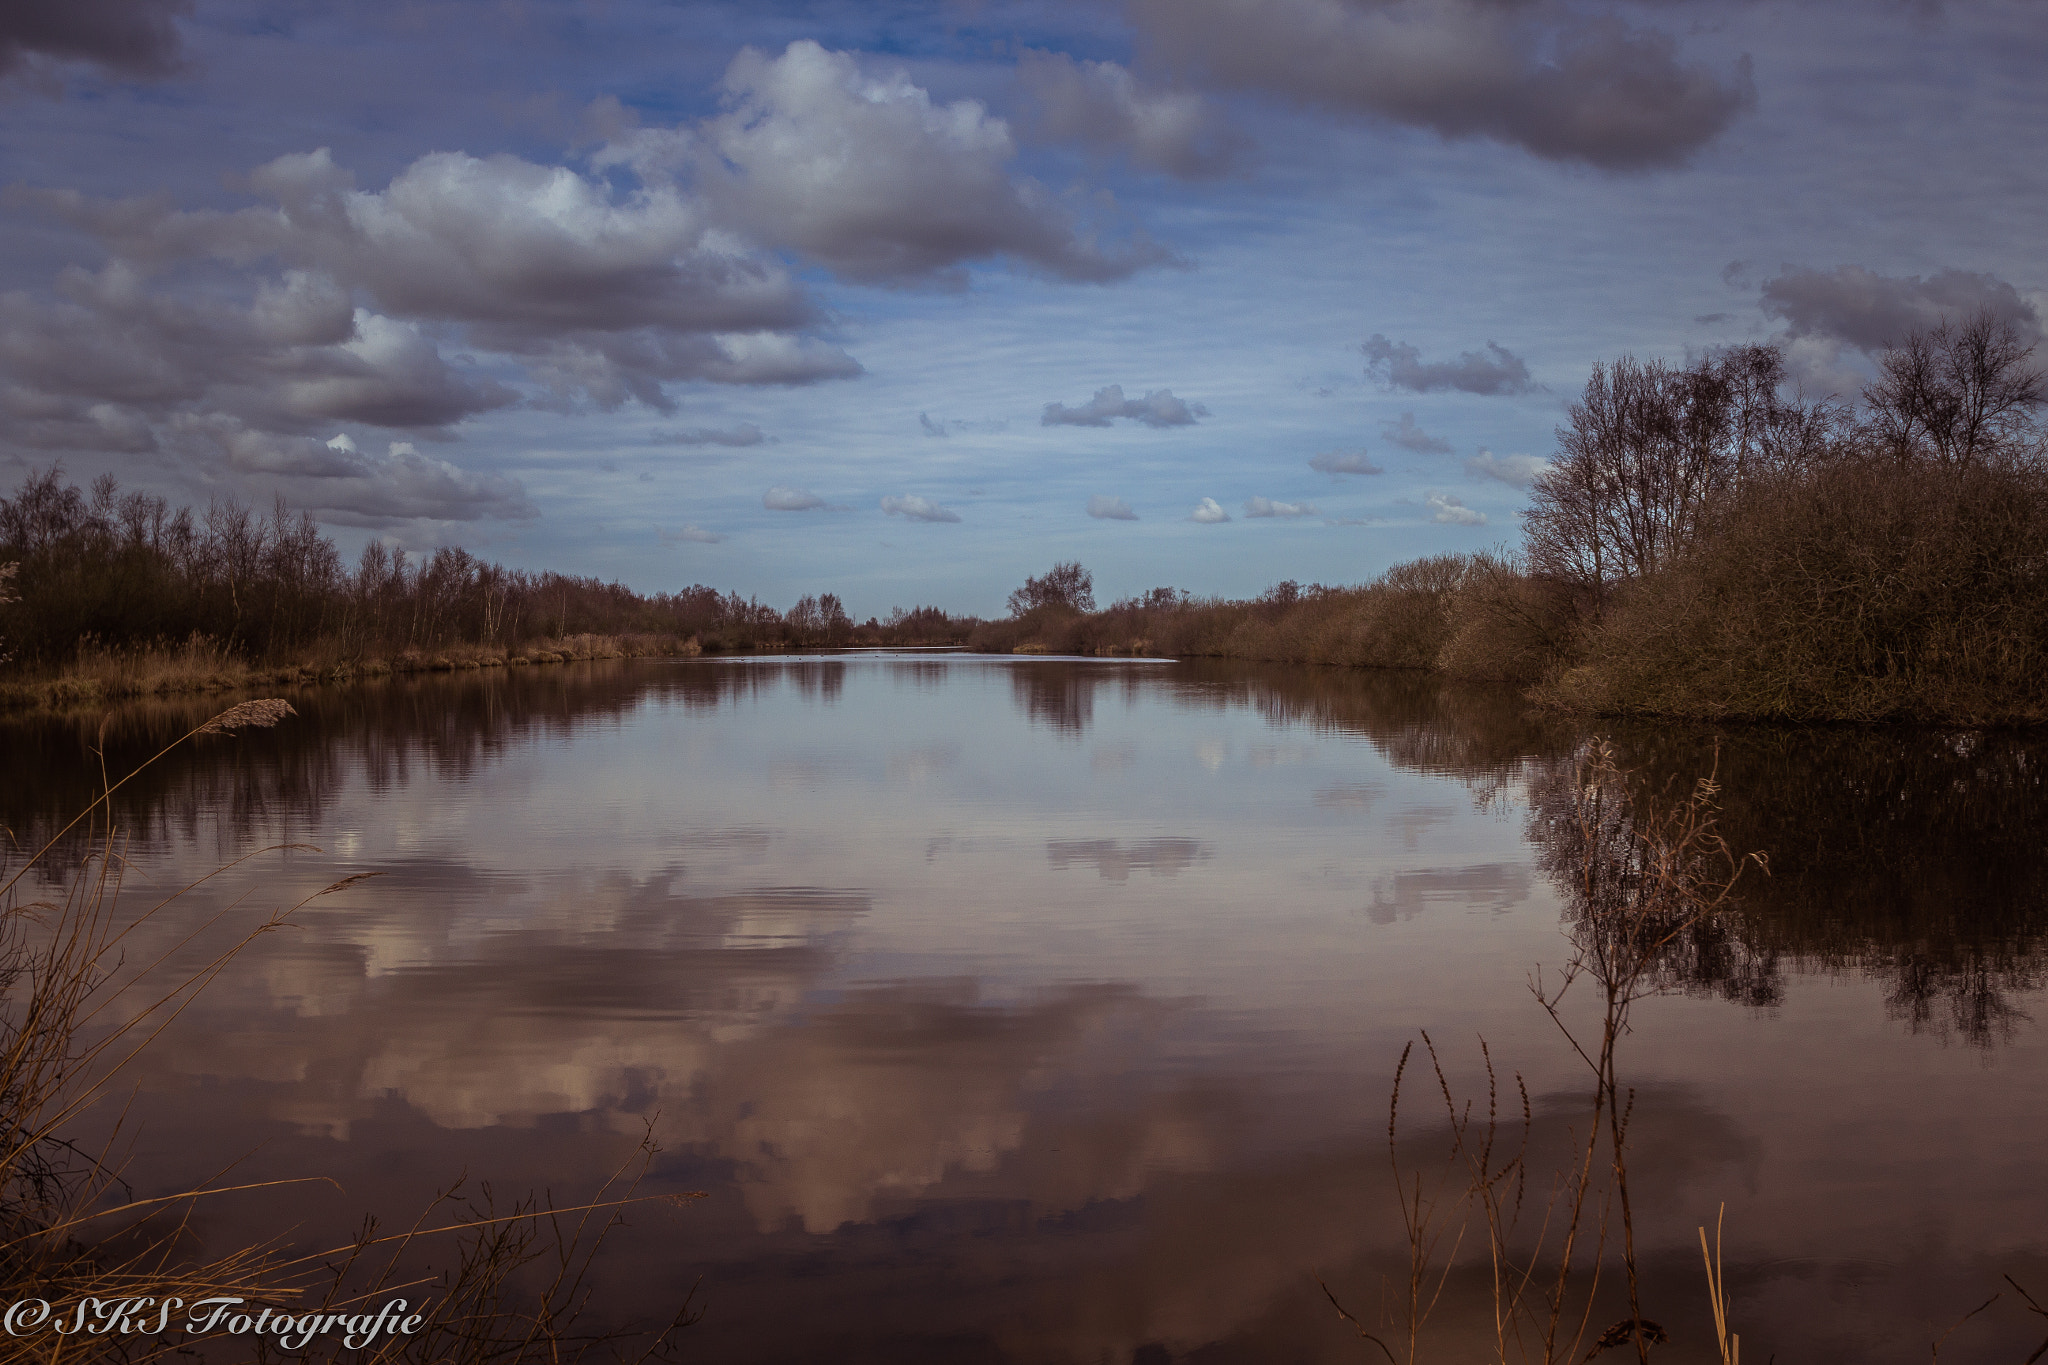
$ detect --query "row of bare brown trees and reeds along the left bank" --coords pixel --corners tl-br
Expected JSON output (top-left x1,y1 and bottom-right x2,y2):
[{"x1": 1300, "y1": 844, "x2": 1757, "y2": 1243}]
[{"x1": 0, "y1": 467, "x2": 971, "y2": 673}]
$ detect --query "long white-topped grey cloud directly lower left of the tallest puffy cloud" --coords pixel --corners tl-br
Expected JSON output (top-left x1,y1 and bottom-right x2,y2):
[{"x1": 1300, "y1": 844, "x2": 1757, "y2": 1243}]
[{"x1": 18, "y1": 147, "x2": 860, "y2": 411}]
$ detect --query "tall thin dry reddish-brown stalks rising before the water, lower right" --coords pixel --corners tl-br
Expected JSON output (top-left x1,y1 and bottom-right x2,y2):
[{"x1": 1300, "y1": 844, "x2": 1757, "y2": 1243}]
[{"x1": 1325, "y1": 743, "x2": 1763, "y2": 1365}]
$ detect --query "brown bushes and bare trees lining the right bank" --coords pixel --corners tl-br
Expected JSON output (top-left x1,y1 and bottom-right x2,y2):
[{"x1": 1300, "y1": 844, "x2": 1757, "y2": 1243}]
[{"x1": 973, "y1": 315, "x2": 2048, "y2": 724}]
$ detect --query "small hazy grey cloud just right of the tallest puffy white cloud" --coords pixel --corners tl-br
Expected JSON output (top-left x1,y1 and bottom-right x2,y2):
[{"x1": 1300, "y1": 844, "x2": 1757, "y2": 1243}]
[{"x1": 1018, "y1": 51, "x2": 1243, "y2": 180}]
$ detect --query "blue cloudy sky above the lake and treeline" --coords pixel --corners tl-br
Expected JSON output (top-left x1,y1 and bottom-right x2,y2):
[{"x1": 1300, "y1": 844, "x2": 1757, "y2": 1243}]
[{"x1": 0, "y1": 0, "x2": 2048, "y2": 618}]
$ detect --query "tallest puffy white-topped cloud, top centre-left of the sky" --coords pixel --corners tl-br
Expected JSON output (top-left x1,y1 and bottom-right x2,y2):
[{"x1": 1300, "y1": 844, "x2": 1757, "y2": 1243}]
[{"x1": 688, "y1": 39, "x2": 1169, "y2": 284}]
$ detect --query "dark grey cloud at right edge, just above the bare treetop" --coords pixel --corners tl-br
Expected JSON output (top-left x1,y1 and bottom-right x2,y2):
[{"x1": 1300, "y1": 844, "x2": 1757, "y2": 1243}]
[{"x1": 1761, "y1": 266, "x2": 2044, "y2": 352}]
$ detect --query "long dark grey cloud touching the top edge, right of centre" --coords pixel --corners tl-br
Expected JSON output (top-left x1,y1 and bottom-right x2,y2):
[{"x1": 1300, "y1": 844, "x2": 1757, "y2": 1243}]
[{"x1": 1130, "y1": 0, "x2": 1755, "y2": 170}]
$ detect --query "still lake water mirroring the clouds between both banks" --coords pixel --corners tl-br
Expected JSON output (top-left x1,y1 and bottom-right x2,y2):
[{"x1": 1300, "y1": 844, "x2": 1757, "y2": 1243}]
[{"x1": 0, "y1": 655, "x2": 2048, "y2": 1365}]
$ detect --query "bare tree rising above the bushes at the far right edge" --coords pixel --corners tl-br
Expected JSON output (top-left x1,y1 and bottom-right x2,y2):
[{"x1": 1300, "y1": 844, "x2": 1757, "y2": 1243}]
[{"x1": 1864, "y1": 311, "x2": 2048, "y2": 469}]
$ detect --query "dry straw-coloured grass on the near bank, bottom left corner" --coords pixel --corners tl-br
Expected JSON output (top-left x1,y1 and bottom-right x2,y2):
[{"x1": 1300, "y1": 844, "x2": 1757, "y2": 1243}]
[{"x1": 0, "y1": 698, "x2": 688, "y2": 1365}]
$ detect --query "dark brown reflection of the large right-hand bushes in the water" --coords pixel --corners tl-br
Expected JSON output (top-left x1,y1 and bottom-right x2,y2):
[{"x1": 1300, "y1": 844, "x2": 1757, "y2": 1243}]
[{"x1": 1589, "y1": 729, "x2": 2048, "y2": 1046}]
